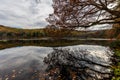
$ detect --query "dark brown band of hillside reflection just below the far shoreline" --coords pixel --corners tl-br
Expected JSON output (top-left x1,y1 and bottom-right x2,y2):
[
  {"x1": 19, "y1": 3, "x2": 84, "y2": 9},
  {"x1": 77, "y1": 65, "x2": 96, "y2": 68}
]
[{"x1": 0, "y1": 39, "x2": 109, "y2": 49}]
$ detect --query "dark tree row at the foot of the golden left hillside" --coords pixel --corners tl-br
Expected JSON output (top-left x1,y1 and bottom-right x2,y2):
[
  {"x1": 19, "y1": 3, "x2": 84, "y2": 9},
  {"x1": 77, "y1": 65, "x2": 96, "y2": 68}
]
[{"x1": 0, "y1": 31, "x2": 45, "y2": 39}]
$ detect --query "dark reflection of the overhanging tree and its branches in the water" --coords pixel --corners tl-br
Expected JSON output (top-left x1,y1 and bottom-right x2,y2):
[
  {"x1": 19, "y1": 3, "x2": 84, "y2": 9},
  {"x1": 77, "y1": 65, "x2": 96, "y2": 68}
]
[{"x1": 44, "y1": 48, "x2": 110, "y2": 80}]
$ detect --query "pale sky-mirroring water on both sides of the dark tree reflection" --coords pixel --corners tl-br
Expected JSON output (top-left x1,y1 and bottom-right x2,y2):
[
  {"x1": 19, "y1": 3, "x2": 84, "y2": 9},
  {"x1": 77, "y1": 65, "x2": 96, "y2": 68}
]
[{"x1": 0, "y1": 45, "x2": 112, "y2": 80}]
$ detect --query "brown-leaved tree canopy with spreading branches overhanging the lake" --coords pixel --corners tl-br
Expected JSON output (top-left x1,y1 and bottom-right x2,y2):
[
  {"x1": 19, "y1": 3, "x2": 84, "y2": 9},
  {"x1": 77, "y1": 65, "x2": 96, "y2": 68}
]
[{"x1": 46, "y1": 0, "x2": 120, "y2": 28}]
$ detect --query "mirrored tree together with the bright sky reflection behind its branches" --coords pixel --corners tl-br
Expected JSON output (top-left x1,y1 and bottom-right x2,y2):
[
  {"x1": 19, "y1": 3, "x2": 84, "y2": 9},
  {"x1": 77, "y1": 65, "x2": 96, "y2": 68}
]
[{"x1": 44, "y1": 45, "x2": 112, "y2": 80}]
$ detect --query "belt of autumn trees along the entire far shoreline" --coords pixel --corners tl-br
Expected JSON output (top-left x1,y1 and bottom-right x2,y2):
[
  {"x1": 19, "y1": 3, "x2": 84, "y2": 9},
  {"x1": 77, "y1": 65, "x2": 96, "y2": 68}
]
[{"x1": 0, "y1": 25, "x2": 120, "y2": 40}]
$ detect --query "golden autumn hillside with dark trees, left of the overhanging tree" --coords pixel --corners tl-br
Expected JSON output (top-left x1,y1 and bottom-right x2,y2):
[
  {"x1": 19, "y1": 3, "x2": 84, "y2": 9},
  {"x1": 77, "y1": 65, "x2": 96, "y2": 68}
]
[{"x1": 0, "y1": 25, "x2": 45, "y2": 39}]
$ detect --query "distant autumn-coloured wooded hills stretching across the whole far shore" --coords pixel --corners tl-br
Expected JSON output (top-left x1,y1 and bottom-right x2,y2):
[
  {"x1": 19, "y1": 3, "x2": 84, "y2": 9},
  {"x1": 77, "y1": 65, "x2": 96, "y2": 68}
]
[{"x1": 0, "y1": 25, "x2": 120, "y2": 40}]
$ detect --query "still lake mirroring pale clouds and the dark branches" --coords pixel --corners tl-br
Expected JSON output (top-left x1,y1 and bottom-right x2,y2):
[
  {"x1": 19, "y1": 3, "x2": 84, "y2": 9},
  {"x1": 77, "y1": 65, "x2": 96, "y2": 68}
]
[{"x1": 0, "y1": 41, "x2": 113, "y2": 80}]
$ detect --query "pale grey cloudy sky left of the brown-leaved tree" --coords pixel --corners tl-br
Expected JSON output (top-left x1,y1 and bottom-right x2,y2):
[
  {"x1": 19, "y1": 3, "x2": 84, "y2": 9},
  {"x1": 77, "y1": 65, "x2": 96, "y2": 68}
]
[{"x1": 0, "y1": 0, "x2": 53, "y2": 29}]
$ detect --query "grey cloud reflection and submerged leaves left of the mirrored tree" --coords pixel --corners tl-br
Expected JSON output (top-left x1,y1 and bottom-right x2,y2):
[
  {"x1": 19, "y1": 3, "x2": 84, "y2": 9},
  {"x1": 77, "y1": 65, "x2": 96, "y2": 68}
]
[{"x1": 0, "y1": 46, "x2": 53, "y2": 80}]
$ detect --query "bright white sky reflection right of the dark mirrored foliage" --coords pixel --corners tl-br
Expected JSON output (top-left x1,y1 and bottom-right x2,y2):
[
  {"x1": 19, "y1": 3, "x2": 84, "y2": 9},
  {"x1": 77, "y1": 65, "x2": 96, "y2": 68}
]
[{"x1": 60, "y1": 45, "x2": 112, "y2": 73}]
